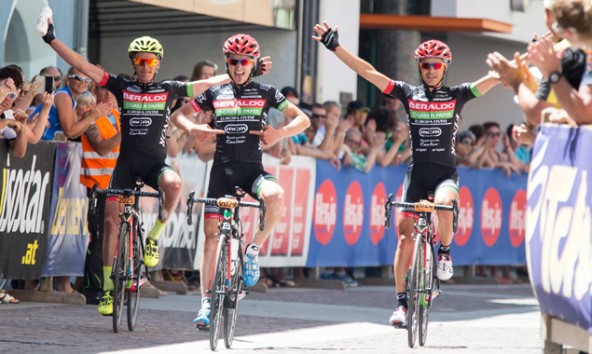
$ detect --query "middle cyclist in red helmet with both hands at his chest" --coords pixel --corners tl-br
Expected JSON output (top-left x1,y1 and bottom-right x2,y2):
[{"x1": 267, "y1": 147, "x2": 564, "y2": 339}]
[{"x1": 172, "y1": 34, "x2": 310, "y2": 327}]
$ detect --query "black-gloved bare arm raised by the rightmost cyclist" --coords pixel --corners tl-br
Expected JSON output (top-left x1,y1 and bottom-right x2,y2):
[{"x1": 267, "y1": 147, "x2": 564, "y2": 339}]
[{"x1": 312, "y1": 22, "x2": 391, "y2": 92}]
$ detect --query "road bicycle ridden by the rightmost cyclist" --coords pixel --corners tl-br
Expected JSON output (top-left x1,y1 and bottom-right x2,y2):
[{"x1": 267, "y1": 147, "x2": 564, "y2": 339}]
[{"x1": 384, "y1": 194, "x2": 458, "y2": 348}]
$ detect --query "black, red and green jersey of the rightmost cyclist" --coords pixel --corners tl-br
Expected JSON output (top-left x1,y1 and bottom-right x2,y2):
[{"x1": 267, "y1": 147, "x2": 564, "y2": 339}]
[{"x1": 383, "y1": 80, "x2": 481, "y2": 167}]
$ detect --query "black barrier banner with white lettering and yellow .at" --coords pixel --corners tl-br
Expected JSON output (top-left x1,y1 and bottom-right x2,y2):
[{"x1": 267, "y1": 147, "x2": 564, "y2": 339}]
[{"x1": 0, "y1": 139, "x2": 55, "y2": 279}]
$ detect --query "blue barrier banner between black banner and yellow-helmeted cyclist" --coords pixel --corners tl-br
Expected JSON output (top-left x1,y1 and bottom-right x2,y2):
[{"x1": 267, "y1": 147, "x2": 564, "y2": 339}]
[{"x1": 43, "y1": 142, "x2": 89, "y2": 276}]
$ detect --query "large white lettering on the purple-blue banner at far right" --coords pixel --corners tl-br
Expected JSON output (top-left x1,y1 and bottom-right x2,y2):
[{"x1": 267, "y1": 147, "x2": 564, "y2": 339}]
[{"x1": 526, "y1": 137, "x2": 592, "y2": 301}]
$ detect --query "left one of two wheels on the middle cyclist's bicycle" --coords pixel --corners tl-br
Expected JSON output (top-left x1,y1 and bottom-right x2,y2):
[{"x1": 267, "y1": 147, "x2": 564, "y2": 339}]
[{"x1": 210, "y1": 235, "x2": 226, "y2": 350}]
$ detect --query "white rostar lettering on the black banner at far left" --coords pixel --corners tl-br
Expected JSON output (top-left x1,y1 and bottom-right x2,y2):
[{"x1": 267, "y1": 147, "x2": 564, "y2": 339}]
[{"x1": 0, "y1": 155, "x2": 49, "y2": 233}]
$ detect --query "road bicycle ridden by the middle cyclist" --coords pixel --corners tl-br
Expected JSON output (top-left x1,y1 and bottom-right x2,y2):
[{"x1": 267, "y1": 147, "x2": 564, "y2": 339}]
[{"x1": 187, "y1": 187, "x2": 265, "y2": 351}]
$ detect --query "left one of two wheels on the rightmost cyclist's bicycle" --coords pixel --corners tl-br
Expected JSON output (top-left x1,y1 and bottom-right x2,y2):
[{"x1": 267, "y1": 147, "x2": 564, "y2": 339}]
[{"x1": 407, "y1": 235, "x2": 423, "y2": 348}]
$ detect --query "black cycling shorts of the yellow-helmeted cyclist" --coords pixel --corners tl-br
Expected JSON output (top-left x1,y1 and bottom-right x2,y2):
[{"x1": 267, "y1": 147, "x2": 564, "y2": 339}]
[{"x1": 109, "y1": 151, "x2": 172, "y2": 190}]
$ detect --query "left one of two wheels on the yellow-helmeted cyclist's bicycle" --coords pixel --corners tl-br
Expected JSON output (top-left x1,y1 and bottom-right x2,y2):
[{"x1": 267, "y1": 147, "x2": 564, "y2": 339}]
[{"x1": 112, "y1": 223, "x2": 129, "y2": 333}]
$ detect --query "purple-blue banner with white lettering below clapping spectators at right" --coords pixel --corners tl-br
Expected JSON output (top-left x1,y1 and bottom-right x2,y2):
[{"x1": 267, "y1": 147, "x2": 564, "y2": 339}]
[{"x1": 526, "y1": 125, "x2": 592, "y2": 333}]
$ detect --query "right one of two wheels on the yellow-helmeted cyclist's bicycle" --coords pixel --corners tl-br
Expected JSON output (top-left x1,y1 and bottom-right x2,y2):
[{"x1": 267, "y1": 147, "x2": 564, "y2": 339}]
[{"x1": 126, "y1": 220, "x2": 147, "y2": 331}]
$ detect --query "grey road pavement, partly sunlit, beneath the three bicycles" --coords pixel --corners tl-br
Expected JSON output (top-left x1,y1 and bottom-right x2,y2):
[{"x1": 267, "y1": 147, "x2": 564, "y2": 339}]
[{"x1": 0, "y1": 285, "x2": 542, "y2": 354}]
